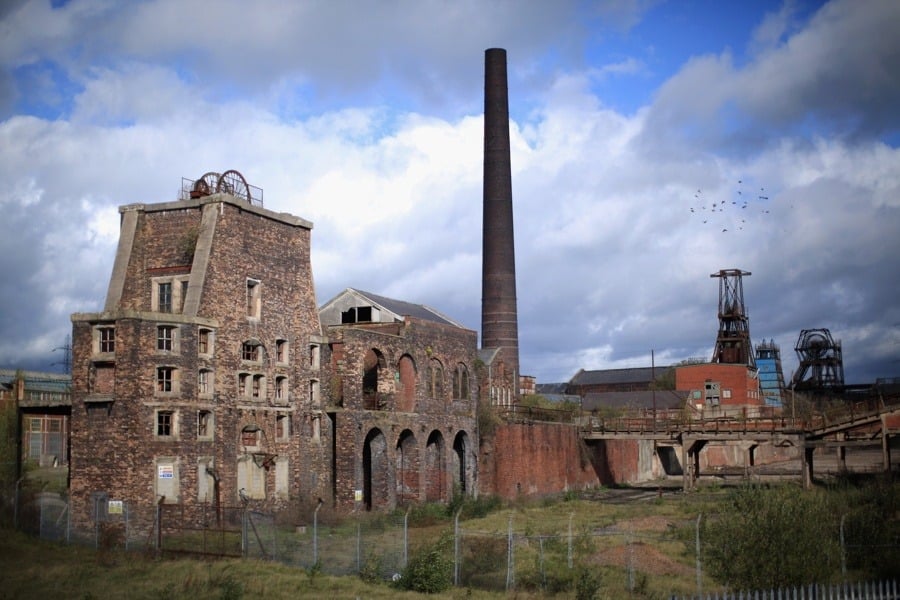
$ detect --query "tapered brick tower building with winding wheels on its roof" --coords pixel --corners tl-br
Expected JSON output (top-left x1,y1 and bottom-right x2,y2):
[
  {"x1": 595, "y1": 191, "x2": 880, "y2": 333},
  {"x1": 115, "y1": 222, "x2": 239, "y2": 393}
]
[{"x1": 71, "y1": 183, "x2": 332, "y2": 523}]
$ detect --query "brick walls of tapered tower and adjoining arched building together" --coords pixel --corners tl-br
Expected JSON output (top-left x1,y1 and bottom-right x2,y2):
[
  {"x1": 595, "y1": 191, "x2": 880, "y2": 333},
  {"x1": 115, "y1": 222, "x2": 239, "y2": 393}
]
[{"x1": 71, "y1": 189, "x2": 479, "y2": 527}]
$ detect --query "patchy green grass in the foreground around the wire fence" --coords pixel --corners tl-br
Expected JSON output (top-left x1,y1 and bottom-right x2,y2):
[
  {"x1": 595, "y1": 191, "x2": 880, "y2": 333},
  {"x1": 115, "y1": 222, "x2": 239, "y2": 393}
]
[{"x1": 7, "y1": 488, "x2": 884, "y2": 600}]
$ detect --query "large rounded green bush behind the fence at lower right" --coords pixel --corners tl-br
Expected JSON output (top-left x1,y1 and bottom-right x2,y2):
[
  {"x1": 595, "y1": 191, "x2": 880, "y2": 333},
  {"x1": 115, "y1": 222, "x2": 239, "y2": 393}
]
[{"x1": 702, "y1": 485, "x2": 840, "y2": 590}]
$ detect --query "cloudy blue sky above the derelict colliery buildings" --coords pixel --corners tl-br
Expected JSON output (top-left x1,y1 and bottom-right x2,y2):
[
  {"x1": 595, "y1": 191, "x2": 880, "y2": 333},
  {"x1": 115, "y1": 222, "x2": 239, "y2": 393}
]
[{"x1": 0, "y1": 0, "x2": 900, "y2": 383}]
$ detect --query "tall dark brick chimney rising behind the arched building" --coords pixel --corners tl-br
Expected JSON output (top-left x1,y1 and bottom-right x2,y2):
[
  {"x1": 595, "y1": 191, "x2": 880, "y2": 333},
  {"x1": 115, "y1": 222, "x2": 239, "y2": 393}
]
[{"x1": 481, "y1": 48, "x2": 519, "y2": 384}]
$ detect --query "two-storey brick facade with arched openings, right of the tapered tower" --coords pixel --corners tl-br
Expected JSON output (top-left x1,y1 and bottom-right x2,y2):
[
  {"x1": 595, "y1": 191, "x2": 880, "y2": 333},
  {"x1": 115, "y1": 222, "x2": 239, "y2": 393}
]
[{"x1": 328, "y1": 317, "x2": 478, "y2": 510}]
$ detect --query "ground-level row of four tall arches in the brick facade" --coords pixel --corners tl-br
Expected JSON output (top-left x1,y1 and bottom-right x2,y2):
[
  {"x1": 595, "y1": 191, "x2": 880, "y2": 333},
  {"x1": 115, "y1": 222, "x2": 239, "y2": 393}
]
[{"x1": 362, "y1": 428, "x2": 474, "y2": 510}]
